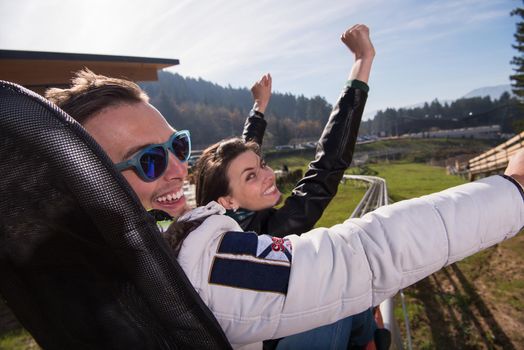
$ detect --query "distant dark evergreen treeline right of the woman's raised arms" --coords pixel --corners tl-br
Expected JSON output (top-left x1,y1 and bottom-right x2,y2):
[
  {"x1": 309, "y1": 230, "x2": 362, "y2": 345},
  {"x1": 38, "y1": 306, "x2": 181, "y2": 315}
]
[{"x1": 360, "y1": 92, "x2": 524, "y2": 136}]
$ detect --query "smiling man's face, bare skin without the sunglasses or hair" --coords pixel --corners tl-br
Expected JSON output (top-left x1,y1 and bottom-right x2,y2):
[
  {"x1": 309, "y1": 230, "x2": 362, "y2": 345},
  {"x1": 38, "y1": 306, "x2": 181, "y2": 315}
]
[{"x1": 84, "y1": 102, "x2": 191, "y2": 217}]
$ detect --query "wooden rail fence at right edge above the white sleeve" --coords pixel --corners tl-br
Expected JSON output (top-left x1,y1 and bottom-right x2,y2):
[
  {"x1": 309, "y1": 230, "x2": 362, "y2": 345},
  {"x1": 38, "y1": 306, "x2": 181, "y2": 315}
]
[{"x1": 468, "y1": 131, "x2": 524, "y2": 180}]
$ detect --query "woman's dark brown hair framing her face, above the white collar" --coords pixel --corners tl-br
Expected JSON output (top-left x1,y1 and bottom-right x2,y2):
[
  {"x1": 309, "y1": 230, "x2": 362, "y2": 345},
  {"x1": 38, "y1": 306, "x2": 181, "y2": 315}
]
[{"x1": 194, "y1": 138, "x2": 260, "y2": 206}]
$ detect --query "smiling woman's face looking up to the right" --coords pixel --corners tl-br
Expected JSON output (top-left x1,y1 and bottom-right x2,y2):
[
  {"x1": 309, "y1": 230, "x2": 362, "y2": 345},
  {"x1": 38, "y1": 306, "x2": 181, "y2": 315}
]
[{"x1": 219, "y1": 151, "x2": 281, "y2": 211}]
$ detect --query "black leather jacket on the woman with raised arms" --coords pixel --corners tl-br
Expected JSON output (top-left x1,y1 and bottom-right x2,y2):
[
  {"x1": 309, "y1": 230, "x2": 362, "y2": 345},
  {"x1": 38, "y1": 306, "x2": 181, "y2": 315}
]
[{"x1": 238, "y1": 82, "x2": 367, "y2": 237}]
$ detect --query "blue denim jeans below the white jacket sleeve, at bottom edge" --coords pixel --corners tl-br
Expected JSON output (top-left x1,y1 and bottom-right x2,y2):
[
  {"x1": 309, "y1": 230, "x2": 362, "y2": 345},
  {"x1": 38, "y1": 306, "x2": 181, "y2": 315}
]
[{"x1": 276, "y1": 309, "x2": 377, "y2": 350}]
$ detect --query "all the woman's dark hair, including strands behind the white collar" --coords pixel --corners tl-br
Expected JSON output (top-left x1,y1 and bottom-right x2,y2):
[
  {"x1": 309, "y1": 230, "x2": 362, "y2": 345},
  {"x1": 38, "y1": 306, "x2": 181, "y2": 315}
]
[{"x1": 164, "y1": 138, "x2": 260, "y2": 256}]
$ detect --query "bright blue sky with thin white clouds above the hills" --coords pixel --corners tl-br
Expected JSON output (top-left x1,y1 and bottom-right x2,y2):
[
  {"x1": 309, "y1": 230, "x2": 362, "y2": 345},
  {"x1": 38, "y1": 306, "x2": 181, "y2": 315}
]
[{"x1": 0, "y1": 0, "x2": 522, "y2": 119}]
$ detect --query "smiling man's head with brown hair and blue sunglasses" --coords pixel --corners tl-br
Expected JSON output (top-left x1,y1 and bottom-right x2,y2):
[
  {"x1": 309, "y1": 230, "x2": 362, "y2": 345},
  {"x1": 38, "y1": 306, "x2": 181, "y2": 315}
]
[{"x1": 46, "y1": 69, "x2": 191, "y2": 217}]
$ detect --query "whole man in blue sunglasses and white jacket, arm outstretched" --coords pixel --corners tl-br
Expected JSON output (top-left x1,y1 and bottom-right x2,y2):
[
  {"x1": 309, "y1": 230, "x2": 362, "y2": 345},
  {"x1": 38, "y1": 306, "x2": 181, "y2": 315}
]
[{"x1": 46, "y1": 65, "x2": 524, "y2": 345}]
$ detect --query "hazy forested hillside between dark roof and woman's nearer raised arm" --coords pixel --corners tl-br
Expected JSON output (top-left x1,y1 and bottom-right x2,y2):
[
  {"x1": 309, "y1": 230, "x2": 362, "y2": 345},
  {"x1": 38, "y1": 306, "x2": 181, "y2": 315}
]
[{"x1": 140, "y1": 71, "x2": 331, "y2": 148}]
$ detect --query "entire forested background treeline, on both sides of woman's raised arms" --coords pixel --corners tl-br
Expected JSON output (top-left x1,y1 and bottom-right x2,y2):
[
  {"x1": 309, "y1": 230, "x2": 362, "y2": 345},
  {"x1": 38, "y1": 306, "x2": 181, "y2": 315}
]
[{"x1": 140, "y1": 72, "x2": 524, "y2": 149}]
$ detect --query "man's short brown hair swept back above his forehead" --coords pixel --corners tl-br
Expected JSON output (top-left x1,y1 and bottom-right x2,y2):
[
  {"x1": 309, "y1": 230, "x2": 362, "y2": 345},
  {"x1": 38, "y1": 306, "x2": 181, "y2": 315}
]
[{"x1": 45, "y1": 68, "x2": 149, "y2": 124}]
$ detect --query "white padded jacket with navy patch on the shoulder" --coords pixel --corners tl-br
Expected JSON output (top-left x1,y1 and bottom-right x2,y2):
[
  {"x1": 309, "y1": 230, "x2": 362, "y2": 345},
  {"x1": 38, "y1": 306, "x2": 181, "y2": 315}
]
[{"x1": 178, "y1": 176, "x2": 524, "y2": 349}]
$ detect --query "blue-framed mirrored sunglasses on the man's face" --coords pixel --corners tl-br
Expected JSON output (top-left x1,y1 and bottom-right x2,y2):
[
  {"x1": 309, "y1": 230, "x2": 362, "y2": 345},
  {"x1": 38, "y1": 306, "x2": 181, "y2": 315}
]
[{"x1": 115, "y1": 130, "x2": 191, "y2": 182}]
